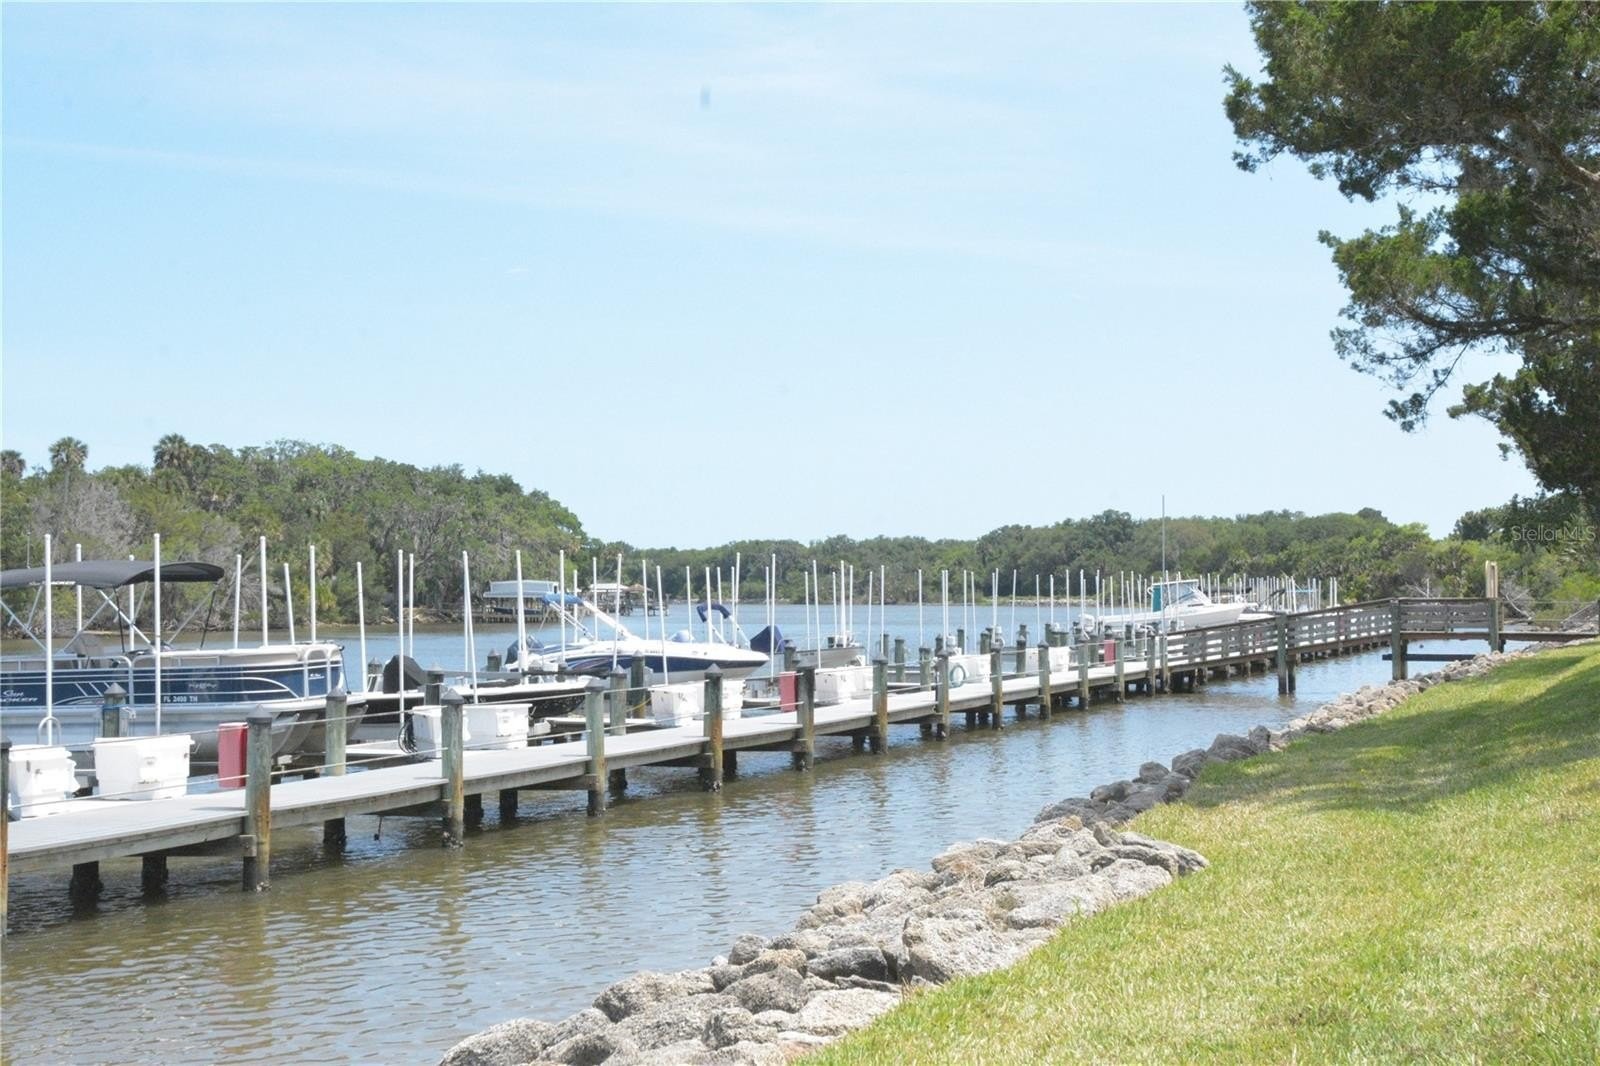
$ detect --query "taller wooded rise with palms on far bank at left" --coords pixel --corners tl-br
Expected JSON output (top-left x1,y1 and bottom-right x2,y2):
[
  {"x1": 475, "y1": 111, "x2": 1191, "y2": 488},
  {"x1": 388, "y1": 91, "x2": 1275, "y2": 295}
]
[{"x1": 0, "y1": 434, "x2": 587, "y2": 626}]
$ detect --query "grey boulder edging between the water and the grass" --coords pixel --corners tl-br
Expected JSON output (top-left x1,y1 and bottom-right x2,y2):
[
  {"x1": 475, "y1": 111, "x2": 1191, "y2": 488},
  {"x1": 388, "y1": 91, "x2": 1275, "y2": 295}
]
[{"x1": 442, "y1": 651, "x2": 1533, "y2": 1066}]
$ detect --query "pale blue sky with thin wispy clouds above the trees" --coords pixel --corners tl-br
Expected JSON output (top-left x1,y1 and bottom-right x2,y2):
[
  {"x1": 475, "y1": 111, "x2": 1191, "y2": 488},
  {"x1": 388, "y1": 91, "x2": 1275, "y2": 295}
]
[{"x1": 0, "y1": 3, "x2": 1533, "y2": 546}]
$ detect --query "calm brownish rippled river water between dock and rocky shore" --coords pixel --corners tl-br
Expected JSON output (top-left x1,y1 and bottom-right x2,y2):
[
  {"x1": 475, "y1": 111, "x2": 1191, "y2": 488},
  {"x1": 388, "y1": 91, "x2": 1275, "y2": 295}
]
[{"x1": 0, "y1": 605, "x2": 1389, "y2": 1063}]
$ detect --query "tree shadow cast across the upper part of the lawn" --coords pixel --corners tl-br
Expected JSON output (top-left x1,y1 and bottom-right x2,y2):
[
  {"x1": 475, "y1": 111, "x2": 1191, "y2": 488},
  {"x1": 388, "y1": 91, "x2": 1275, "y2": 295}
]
[{"x1": 1189, "y1": 655, "x2": 1600, "y2": 815}]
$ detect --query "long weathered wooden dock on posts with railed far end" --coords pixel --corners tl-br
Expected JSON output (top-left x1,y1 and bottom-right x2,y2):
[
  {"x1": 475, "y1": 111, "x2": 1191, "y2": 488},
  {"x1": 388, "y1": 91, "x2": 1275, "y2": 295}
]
[{"x1": 0, "y1": 599, "x2": 1595, "y2": 919}]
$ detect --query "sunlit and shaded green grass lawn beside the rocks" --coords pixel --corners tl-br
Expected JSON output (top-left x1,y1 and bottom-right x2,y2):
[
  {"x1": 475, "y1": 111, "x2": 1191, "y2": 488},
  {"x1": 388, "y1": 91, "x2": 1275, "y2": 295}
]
[{"x1": 806, "y1": 645, "x2": 1600, "y2": 1064}]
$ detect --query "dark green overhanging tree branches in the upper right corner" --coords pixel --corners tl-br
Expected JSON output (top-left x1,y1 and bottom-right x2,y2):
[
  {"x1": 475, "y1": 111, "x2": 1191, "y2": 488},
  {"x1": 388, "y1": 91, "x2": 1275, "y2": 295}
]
[{"x1": 1226, "y1": 2, "x2": 1600, "y2": 507}]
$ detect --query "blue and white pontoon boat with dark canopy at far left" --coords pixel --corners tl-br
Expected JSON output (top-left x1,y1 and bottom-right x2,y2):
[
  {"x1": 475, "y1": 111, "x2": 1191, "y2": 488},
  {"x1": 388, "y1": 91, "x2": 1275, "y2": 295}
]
[{"x1": 0, "y1": 560, "x2": 360, "y2": 758}]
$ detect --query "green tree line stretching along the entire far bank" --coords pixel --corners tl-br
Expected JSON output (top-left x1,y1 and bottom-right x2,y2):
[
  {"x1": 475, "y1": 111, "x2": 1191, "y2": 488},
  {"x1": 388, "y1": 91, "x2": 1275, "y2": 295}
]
[{"x1": 0, "y1": 434, "x2": 1600, "y2": 626}]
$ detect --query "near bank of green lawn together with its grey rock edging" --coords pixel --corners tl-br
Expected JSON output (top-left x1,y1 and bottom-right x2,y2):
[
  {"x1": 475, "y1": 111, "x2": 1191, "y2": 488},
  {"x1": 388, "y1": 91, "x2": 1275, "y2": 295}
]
[{"x1": 445, "y1": 645, "x2": 1600, "y2": 1066}]
